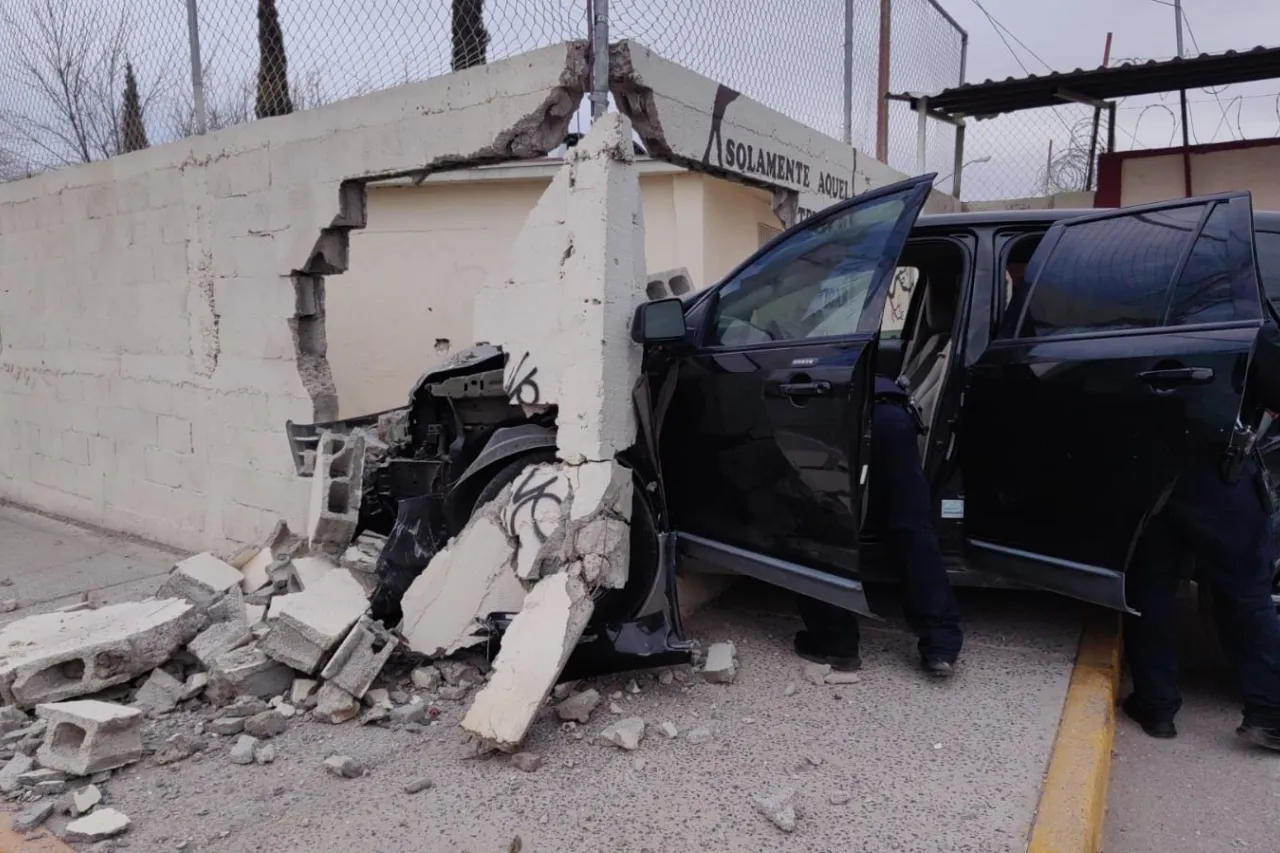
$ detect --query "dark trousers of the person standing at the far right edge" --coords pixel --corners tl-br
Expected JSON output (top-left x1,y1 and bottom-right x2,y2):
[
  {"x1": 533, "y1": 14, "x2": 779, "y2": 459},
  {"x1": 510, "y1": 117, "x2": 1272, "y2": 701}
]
[{"x1": 1124, "y1": 461, "x2": 1280, "y2": 729}]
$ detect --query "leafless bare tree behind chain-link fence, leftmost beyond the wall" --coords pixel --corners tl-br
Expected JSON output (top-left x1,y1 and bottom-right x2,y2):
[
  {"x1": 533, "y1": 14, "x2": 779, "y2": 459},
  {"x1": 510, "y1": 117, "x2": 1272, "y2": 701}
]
[{"x1": 0, "y1": 0, "x2": 163, "y2": 169}]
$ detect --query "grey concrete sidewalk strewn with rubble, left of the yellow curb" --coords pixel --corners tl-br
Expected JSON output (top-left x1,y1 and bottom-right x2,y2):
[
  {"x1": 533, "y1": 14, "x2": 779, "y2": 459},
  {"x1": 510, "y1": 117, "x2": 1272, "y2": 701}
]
[{"x1": 0, "y1": 507, "x2": 1080, "y2": 853}]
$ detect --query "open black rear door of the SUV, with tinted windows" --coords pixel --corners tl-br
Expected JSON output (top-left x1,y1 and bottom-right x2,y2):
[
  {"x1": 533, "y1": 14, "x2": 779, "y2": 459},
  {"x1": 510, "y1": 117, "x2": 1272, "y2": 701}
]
[{"x1": 960, "y1": 192, "x2": 1262, "y2": 610}]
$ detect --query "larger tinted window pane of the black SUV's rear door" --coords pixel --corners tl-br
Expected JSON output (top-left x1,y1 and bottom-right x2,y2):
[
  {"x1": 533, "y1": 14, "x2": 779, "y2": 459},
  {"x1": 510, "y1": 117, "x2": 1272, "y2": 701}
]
[{"x1": 1018, "y1": 204, "x2": 1204, "y2": 338}]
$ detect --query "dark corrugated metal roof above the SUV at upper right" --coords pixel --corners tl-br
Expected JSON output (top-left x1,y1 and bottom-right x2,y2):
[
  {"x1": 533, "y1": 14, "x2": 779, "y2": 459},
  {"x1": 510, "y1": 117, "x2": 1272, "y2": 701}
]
[{"x1": 896, "y1": 46, "x2": 1280, "y2": 118}]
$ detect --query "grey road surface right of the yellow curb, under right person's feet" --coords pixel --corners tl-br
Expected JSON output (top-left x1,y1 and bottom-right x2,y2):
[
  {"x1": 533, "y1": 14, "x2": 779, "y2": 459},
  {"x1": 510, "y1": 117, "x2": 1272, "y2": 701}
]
[{"x1": 1103, "y1": 589, "x2": 1280, "y2": 853}]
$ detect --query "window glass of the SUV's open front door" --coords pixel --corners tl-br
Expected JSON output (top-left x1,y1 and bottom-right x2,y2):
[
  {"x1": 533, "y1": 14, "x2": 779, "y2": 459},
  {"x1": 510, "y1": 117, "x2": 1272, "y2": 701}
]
[{"x1": 707, "y1": 187, "x2": 914, "y2": 346}]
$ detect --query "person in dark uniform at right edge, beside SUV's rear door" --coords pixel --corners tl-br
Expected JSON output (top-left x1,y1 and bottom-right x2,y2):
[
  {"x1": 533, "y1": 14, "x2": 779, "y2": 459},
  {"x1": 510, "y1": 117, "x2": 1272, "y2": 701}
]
[{"x1": 1121, "y1": 317, "x2": 1280, "y2": 751}]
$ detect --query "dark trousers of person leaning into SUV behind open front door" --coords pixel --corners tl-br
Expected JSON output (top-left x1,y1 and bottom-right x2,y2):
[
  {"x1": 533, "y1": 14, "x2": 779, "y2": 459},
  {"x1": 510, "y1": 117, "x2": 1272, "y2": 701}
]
[{"x1": 799, "y1": 402, "x2": 964, "y2": 662}]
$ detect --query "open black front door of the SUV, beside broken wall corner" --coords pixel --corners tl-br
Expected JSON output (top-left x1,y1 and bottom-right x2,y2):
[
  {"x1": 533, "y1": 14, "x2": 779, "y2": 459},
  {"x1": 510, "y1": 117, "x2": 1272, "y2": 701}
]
[{"x1": 662, "y1": 175, "x2": 932, "y2": 612}]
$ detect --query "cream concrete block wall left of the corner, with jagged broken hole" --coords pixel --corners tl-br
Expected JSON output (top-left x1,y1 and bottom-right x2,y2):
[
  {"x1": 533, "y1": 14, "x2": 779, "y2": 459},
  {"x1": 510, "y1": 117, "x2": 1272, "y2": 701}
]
[{"x1": 0, "y1": 45, "x2": 585, "y2": 549}]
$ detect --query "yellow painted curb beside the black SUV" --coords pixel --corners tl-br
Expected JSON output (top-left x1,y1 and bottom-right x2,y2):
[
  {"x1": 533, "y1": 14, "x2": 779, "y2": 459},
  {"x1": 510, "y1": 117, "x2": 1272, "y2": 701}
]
[{"x1": 1027, "y1": 611, "x2": 1120, "y2": 853}]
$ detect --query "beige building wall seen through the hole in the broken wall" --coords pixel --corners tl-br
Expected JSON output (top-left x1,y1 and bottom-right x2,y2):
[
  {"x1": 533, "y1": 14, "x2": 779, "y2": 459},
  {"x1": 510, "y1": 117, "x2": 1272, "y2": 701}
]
[{"x1": 325, "y1": 160, "x2": 781, "y2": 418}]
